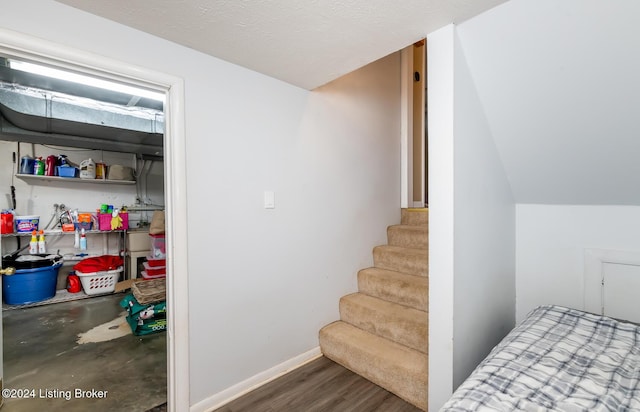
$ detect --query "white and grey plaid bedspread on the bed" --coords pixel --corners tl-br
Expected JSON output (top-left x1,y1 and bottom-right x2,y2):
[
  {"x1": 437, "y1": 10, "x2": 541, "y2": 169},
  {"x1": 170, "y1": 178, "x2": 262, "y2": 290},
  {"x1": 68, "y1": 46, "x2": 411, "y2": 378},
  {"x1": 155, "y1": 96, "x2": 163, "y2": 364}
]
[{"x1": 441, "y1": 306, "x2": 640, "y2": 412}]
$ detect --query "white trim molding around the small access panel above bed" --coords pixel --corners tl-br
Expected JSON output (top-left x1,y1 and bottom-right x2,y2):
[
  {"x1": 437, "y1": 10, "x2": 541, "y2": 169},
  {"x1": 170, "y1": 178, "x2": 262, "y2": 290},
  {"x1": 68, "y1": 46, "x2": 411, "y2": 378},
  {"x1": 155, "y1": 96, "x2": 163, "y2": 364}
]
[{"x1": 583, "y1": 249, "x2": 640, "y2": 314}]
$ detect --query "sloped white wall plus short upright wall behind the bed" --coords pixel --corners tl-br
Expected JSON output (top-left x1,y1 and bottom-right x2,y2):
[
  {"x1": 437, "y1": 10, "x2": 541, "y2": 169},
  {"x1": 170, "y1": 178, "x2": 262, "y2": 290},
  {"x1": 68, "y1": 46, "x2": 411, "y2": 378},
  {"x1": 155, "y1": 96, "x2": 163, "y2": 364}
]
[{"x1": 458, "y1": 0, "x2": 640, "y2": 334}]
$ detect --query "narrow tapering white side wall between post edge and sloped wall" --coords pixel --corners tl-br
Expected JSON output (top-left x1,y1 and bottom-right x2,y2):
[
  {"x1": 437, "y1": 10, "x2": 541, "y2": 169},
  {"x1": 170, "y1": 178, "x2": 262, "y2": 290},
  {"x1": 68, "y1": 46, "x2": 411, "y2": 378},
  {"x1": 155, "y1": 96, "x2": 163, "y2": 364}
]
[{"x1": 453, "y1": 33, "x2": 516, "y2": 387}]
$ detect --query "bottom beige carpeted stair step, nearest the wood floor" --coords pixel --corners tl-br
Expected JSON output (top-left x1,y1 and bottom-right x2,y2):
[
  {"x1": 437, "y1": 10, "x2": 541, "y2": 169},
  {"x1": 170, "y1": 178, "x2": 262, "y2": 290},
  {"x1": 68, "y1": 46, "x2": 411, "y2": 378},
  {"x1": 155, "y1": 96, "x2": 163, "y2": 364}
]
[{"x1": 319, "y1": 322, "x2": 428, "y2": 411}]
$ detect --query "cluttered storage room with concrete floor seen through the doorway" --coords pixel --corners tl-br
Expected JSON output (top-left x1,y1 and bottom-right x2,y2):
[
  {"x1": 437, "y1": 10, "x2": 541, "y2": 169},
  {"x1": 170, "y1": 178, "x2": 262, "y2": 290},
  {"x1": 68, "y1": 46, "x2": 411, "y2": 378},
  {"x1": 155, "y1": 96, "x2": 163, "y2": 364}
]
[{"x1": 0, "y1": 56, "x2": 167, "y2": 411}]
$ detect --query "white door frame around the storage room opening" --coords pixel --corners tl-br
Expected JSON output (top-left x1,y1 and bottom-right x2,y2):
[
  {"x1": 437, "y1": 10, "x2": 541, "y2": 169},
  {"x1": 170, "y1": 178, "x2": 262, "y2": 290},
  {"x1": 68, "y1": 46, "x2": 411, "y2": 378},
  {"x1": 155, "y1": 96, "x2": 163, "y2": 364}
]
[{"x1": 0, "y1": 28, "x2": 189, "y2": 411}]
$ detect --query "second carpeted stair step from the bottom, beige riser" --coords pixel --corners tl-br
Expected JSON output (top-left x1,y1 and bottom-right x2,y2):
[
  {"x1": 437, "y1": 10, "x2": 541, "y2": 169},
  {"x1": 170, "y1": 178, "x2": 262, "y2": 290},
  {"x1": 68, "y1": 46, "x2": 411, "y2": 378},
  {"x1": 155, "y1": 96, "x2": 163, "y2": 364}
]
[{"x1": 340, "y1": 297, "x2": 429, "y2": 353}]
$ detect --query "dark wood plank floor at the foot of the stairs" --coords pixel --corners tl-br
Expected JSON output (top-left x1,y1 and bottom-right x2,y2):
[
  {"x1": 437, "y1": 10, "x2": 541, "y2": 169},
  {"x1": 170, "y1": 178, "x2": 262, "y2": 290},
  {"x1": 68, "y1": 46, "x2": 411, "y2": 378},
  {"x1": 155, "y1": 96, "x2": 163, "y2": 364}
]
[{"x1": 215, "y1": 357, "x2": 420, "y2": 412}]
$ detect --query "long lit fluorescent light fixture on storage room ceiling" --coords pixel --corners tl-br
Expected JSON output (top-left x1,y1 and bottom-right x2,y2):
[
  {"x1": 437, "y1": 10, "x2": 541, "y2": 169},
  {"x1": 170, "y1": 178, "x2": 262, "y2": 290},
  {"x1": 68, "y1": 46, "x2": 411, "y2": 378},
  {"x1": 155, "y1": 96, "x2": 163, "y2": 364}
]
[{"x1": 9, "y1": 60, "x2": 165, "y2": 102}]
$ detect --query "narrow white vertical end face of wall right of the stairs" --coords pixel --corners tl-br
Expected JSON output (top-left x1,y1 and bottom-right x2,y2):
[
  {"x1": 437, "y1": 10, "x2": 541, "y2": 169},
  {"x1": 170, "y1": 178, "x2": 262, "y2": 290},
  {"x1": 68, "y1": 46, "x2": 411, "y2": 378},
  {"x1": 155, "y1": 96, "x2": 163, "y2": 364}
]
[{"x1": 427, "y1": 25, "x2": 455, "y2": 411}]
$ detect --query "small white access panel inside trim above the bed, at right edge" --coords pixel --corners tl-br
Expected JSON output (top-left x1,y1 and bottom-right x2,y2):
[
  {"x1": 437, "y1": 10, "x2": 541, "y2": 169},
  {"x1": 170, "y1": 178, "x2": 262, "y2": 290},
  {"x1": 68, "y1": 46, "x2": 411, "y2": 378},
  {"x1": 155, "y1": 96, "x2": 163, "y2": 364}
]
[{"x1": 602, "y1": 263, "x2": 640, "y2": 323}]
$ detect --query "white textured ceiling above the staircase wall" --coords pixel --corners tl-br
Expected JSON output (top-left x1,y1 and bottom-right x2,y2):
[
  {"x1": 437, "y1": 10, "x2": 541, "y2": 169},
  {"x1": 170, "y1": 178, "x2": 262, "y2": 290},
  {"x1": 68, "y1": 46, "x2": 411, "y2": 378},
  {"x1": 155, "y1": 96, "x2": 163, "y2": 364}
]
[{"x1": 57, "y1": 0, "x2": 506, "y2": 89}]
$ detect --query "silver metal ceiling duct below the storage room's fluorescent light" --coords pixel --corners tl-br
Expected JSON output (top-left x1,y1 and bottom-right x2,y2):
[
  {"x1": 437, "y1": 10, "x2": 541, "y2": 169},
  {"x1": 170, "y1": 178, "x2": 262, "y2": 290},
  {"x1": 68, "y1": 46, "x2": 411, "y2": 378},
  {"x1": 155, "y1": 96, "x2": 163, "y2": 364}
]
[{"x1": 0, "y1": 67, "x2": 164, "y2": 156}]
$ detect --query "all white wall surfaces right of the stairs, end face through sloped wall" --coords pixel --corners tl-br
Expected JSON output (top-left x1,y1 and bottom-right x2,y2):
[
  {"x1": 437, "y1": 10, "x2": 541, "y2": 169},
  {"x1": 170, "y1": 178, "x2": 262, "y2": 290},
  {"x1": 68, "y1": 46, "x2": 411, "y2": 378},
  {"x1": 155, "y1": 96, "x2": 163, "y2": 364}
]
[{"x1": 428, "y1": 0, "x2": 640, "y2": 409}]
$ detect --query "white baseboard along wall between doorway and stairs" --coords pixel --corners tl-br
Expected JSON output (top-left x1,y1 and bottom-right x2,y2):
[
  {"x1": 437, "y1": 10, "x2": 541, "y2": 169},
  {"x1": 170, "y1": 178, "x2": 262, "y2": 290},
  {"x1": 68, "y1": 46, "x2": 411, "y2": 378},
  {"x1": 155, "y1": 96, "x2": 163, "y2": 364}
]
[{"x1": 189, "y1": 346, "x2": 322, "y2": 412}]
